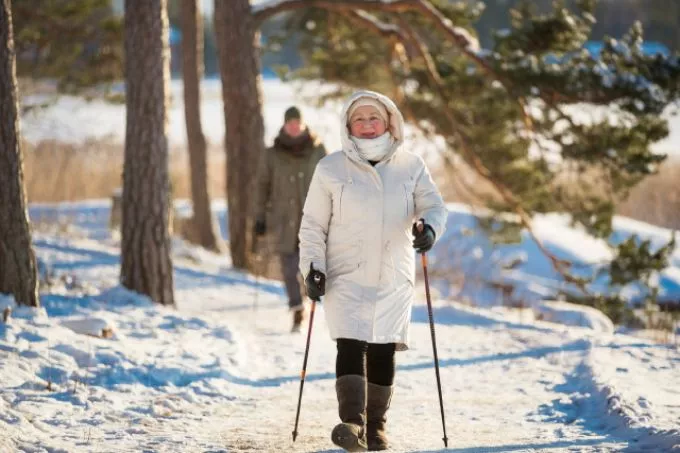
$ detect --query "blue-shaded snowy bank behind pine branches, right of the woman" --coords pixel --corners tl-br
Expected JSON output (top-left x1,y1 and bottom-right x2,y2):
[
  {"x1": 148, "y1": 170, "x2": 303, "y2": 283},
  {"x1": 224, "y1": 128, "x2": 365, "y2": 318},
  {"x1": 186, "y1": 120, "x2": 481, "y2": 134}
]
[{"x1": 432, "y1": 203, "x2": 680, "y2": 306}]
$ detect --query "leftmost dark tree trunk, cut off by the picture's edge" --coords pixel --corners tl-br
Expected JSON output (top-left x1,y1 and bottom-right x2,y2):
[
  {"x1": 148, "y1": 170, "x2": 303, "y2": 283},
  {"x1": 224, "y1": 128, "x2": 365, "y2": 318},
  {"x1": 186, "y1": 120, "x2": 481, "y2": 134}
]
[{"x1": 0, "y1": 0, "x2": 39, "y2": 307}]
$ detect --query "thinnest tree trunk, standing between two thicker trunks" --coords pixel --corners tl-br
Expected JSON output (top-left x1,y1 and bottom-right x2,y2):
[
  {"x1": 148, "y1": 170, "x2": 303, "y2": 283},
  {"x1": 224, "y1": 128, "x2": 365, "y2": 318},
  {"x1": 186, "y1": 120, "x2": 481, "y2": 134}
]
[{"x1": 182, "y1": 0, "x2": 220, "y2": 252}]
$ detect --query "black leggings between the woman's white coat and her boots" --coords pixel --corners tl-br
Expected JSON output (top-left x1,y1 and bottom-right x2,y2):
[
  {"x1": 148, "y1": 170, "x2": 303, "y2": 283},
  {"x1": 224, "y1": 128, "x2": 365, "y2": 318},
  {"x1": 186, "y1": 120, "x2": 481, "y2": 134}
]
[{"x1": 335, "y1": 338, "x2": 396, "y2": 386}]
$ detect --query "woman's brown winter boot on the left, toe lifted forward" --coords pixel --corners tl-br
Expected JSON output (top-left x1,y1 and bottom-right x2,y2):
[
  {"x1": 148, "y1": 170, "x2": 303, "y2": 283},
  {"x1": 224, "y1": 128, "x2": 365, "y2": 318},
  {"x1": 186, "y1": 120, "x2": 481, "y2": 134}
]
[{"x1": 331, "y1": 374, "x2": 367, "y2": 452}]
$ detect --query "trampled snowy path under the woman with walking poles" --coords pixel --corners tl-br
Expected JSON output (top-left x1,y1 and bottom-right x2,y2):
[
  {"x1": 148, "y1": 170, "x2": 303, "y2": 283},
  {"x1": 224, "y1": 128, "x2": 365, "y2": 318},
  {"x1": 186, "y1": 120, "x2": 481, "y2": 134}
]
[{"x1": 183, "y1": 286, "x2": 624, "y2": 452}]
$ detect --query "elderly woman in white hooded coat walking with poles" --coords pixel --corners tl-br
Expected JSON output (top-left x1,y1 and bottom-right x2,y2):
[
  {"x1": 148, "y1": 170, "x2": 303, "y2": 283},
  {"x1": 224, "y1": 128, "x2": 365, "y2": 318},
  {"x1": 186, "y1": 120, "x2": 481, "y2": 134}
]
[{"x1": 299, "y1": 91, "x2": 447, "y2": 451}]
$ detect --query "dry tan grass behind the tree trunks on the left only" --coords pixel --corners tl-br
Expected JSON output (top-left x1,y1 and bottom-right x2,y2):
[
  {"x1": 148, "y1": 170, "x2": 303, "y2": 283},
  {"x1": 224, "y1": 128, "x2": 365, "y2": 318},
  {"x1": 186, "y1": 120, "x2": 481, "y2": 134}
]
[{"x1": 24, "y1": 141, "x2": 225, "y2": 203}]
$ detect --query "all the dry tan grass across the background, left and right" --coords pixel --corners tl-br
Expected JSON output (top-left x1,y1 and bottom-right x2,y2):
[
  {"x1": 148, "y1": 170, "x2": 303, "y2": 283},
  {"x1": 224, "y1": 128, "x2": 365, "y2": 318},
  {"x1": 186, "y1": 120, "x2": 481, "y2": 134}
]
[{"x1": 24, "y1": 141, "x2": 680, "y2": 235}]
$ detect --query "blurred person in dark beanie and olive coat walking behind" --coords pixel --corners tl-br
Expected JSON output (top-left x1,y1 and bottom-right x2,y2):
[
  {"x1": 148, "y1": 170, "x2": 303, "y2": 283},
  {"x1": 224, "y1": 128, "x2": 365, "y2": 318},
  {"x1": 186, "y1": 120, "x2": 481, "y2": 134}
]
[{"x1": 253, "y1": 106, "x2": 326, "y2": 331}]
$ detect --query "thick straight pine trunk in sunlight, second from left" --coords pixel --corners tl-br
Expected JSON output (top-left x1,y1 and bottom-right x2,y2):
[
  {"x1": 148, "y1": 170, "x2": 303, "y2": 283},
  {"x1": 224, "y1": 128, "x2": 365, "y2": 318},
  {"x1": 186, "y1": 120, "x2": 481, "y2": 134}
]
[{"x1": 120, "y1": 0, "x2": 175, "y2": 305}]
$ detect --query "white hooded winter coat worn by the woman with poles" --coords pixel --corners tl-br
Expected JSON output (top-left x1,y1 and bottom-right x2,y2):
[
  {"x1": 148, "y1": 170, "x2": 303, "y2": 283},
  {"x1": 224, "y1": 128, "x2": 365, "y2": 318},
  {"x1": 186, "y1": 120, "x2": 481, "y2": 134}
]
[{"x1": 299, "y1": 91, "x2": 447, "y2": 350}]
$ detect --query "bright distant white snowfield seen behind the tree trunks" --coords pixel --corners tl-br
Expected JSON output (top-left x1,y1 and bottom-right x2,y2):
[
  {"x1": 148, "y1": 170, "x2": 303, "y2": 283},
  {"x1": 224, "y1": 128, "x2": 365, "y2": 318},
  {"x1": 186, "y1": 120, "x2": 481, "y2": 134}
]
[{"x1": 21, "y1": 79, "x2": 680, "y2": 154}]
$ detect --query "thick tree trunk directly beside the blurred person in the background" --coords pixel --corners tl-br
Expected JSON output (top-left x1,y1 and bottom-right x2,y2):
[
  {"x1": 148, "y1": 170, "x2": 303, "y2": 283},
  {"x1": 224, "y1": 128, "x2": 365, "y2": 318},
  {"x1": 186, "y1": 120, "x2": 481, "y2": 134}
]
[{"x1": 215, "y1": 0, "x2": 264, "y2": 269}]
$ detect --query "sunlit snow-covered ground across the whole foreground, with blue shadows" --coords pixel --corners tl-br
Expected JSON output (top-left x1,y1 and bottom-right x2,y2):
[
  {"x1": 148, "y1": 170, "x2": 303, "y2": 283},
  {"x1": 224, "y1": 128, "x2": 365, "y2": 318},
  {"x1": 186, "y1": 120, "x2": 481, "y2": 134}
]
[{"x1": 0, "y1": 201, "x2": 680, "y2": 452}]
